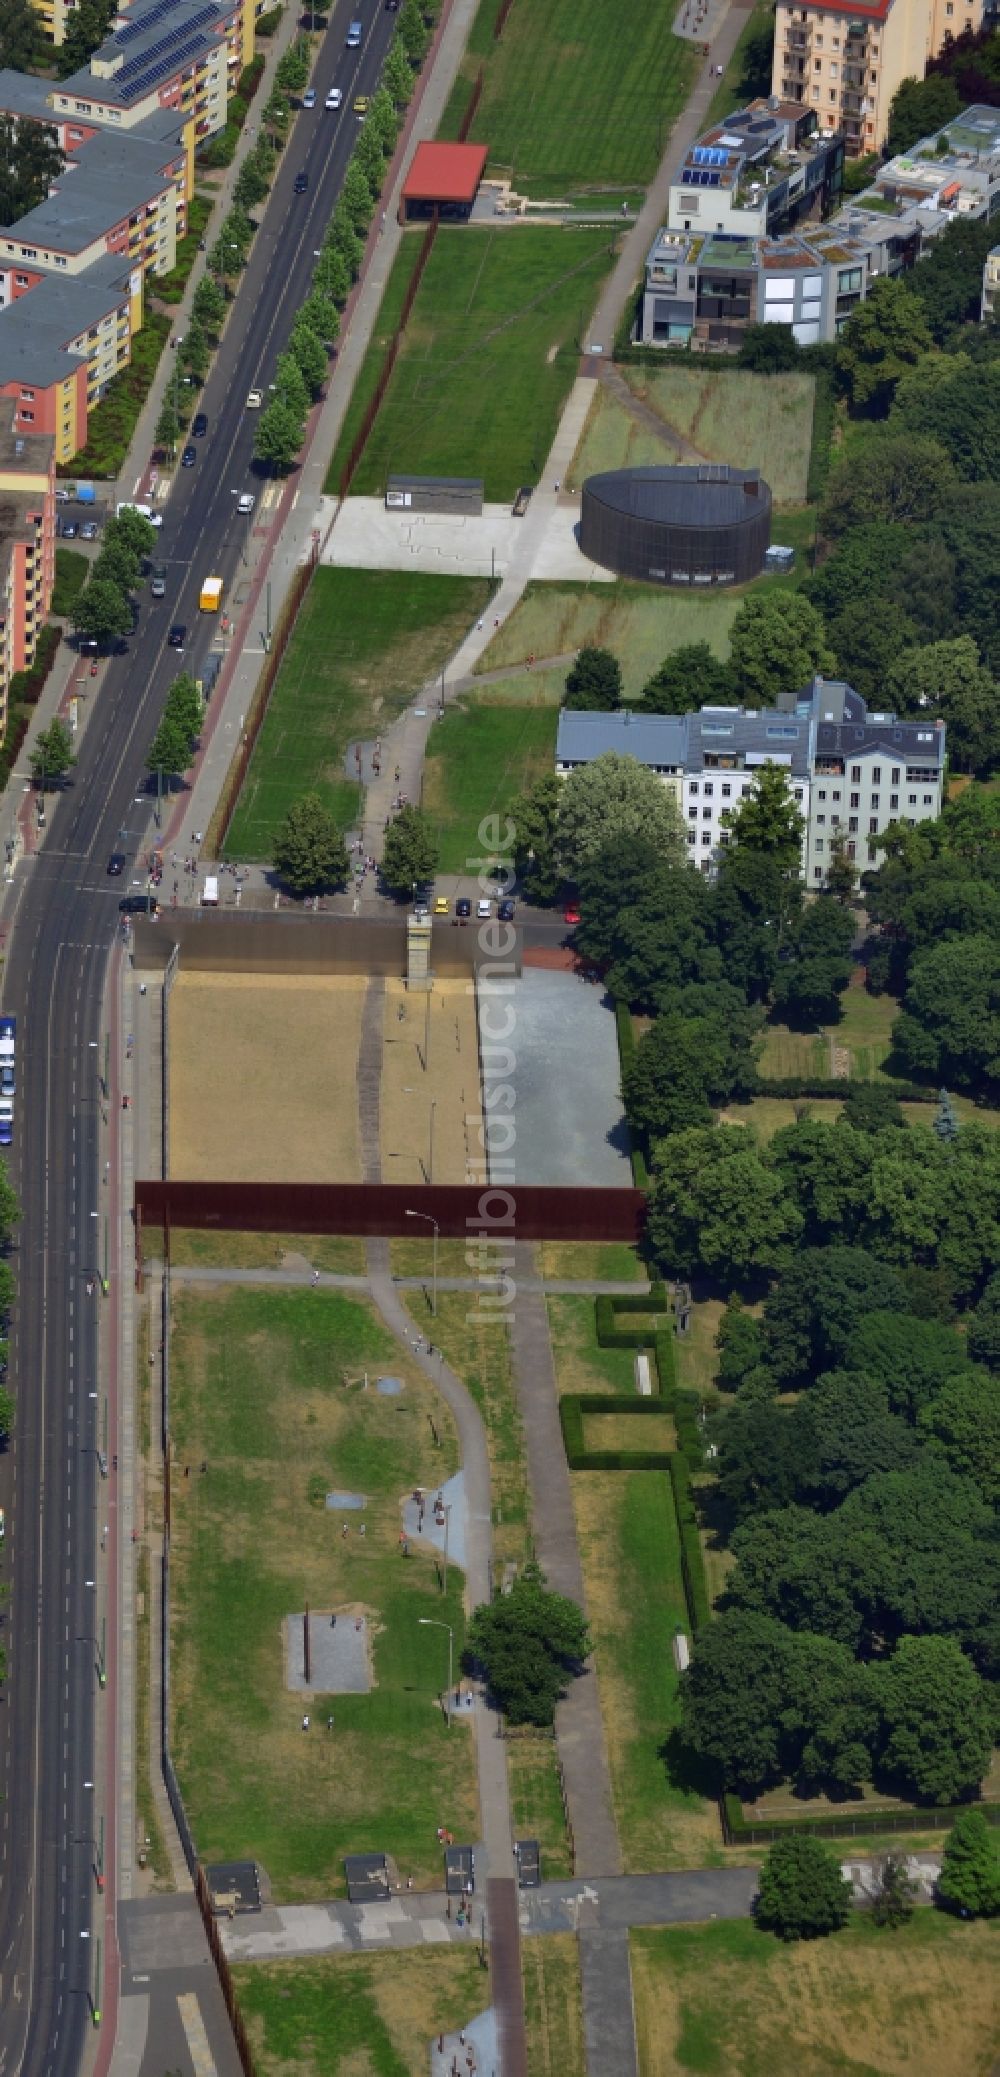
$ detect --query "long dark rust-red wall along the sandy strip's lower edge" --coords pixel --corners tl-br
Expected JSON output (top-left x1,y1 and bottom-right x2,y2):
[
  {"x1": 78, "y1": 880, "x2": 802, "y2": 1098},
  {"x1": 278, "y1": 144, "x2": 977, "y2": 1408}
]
[{"x1": 135, "y1": 1178, "x2": 647, "y2": 1242}]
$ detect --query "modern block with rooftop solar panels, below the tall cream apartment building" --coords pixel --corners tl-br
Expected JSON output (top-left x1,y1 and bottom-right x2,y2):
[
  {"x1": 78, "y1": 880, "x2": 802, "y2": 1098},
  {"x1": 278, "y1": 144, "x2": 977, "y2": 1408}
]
[{"x1": 669, "y1": 98, "x2": 844, "y2": 239}]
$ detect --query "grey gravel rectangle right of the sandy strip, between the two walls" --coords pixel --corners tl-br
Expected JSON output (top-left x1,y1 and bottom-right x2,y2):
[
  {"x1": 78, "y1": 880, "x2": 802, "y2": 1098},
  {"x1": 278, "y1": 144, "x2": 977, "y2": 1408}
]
[{"x1": 480, "y1": 966, "x2": 632, "y2": 1190}]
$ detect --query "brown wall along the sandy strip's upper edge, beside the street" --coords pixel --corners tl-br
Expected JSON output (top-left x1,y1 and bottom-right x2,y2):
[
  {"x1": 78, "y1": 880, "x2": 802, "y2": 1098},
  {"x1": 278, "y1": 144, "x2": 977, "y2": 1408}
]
[{"x1": 135, "y1": 910, "x2": 522, "y2": 980}]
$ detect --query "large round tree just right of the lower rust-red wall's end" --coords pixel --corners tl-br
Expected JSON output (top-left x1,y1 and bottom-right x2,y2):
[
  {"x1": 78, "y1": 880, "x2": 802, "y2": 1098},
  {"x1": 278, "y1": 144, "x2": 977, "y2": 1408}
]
[{"x1": 647, "y1": 1126, "x2": 802, "y2": 1290}]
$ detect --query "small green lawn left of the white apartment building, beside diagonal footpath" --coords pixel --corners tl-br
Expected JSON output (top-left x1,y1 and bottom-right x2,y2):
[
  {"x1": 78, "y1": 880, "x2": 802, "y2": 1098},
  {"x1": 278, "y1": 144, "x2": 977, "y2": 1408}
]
[{"x1": 422, "y1": 692, "x2": 559, "y2": 872}]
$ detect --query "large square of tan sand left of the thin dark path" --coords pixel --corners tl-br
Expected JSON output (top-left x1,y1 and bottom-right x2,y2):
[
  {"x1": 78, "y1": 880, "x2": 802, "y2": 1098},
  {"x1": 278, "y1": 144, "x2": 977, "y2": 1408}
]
[{"x1": 170, "y1": 972, "x2": 366, "y2": 1182}]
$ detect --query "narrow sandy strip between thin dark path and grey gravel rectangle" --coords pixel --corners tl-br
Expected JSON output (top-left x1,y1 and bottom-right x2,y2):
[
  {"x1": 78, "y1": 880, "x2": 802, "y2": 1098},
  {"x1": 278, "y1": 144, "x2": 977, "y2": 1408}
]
[{"x1": 378, "y1": 978, "x2": 482, "y2": 1188}]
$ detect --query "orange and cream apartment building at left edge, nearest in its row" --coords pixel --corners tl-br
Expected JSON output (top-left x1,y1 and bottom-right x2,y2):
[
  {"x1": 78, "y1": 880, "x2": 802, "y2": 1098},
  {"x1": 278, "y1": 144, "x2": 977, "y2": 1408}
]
[{"x1": 0, "y1": 407, "x2": 56, "y2": 735}]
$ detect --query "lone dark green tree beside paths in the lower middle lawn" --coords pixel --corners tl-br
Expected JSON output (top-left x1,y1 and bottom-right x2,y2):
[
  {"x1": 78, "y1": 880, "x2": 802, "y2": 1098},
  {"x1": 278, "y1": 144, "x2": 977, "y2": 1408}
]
[{"x1": 466, "y1": 1564, "x2": 590, "y2": 1726}]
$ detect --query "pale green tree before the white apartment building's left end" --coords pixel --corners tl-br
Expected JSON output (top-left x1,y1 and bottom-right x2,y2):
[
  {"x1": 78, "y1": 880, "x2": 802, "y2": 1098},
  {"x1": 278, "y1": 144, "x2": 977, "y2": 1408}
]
[{"x1": 555, "y1": 750, "x2": 686, "y2": 881}]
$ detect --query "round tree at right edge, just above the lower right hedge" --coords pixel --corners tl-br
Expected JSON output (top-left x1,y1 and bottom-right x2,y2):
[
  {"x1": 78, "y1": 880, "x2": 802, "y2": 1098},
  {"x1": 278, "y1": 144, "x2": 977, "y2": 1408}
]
[{"x1": 877, "y1": 1637, "x2": 992, "y2": 1803}]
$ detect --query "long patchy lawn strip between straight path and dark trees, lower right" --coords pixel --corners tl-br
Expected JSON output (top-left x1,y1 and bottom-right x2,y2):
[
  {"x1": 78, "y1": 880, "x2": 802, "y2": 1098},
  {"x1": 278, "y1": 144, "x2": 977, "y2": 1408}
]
[{"x1": 572, "y1": 1471, "x2": 721, "y2": 1873}]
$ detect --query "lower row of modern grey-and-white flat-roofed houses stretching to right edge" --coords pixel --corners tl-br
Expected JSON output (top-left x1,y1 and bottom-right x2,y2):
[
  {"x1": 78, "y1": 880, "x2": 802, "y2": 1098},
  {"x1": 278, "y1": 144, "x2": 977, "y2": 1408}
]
[{"x1": 638, "y1": 106, "x2": 1000, "y2": 351}]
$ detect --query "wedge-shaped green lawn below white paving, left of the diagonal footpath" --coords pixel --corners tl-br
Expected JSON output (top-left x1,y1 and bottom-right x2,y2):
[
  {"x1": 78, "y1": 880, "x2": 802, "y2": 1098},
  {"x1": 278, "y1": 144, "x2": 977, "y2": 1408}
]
[{"x1": 225, "y1": 569, "x2": 489, "y2": 858}]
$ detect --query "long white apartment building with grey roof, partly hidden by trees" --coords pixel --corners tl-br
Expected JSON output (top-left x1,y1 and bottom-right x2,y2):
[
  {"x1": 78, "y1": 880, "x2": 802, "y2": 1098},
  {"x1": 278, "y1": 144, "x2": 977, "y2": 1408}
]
[{"x1": 555, "y1": 677, "x2": 946, "y2": 889}]
